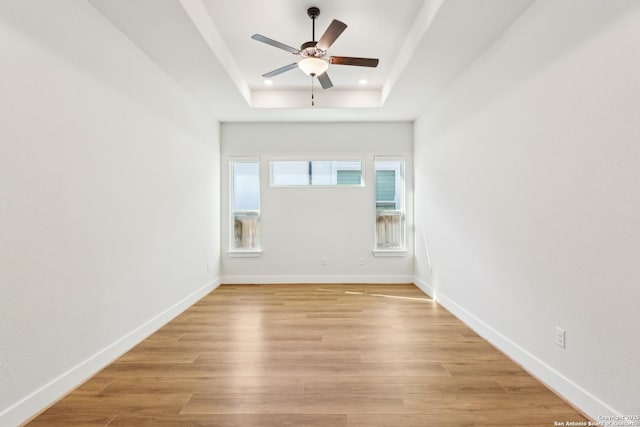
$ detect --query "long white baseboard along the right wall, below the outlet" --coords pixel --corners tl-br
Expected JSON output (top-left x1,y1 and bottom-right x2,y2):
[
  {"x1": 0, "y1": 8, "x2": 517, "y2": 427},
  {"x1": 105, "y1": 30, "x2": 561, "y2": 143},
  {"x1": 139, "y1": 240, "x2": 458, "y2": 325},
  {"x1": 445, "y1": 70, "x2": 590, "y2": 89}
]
[{"x1": 414, "y1": 277, "x2": 622, "y2": 420}]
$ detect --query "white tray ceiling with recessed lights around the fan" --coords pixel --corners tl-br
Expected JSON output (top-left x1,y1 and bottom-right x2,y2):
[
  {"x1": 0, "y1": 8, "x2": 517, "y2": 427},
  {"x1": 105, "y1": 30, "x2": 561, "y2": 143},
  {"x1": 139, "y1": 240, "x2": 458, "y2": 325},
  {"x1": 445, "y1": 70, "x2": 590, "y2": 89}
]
[{"x1": 89, "y1": 0, "x2": 534, "y2": 122}]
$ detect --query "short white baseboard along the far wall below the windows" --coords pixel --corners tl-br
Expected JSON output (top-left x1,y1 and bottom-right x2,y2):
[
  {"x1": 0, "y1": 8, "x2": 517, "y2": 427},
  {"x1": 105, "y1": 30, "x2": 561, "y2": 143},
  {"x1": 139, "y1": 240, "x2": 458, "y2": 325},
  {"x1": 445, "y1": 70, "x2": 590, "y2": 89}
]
[{"x1": 222, "y1": 275, "x2": 414, "y2": 285}]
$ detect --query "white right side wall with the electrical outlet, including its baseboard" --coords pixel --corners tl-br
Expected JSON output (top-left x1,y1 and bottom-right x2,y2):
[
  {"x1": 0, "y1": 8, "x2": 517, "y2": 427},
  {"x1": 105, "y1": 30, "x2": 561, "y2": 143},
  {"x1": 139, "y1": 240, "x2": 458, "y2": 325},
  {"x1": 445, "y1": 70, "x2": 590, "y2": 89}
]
[{"x1": 414, "y1": 0, "x2": 640, "y2": 417}]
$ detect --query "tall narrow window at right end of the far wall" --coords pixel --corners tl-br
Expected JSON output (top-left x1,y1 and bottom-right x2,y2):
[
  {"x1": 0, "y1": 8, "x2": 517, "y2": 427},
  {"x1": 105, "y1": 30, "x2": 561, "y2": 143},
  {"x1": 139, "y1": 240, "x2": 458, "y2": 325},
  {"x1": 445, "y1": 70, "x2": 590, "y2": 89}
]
[{"x1": 374, "y1": 158, "x2": 405, "y2": 251}]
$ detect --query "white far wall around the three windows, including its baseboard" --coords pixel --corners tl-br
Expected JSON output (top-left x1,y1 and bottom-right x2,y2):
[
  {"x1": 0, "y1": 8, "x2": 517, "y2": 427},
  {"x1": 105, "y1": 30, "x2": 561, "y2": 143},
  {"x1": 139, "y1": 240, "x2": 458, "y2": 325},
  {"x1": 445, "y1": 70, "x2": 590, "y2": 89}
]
[{"x1": 221, "y1": 123, "x2": 413, "y2": 283}]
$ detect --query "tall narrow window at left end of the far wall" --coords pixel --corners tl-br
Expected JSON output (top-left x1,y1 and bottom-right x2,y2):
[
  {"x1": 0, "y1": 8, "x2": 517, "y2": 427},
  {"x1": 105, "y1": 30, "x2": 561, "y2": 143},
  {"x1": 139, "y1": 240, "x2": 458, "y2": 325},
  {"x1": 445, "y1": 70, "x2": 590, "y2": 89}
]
[{"x1": 229, "y1": 159, "x2": 260, "y2": 252}]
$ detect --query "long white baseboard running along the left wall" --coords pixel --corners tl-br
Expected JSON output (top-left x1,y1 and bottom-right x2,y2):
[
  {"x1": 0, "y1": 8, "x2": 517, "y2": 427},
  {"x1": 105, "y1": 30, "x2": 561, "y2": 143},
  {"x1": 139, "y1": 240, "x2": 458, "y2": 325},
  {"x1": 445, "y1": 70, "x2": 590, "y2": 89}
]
[{"x1": 0, "y1": 279, "x2": 221, "y2": 426}]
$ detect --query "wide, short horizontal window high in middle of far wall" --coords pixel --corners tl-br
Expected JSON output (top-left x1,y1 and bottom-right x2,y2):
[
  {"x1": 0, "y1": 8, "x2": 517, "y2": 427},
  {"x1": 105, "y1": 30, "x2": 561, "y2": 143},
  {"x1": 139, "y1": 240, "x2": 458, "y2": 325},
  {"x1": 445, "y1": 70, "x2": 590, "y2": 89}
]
[{"x1": 271, "y1": 160, "x2": 363, "y2": 187}]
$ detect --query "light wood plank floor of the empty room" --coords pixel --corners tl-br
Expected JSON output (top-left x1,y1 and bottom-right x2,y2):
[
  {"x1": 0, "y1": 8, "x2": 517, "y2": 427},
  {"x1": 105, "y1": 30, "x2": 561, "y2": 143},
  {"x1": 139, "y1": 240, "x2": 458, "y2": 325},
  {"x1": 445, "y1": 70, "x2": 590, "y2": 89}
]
[{"x1": 29, "y1": 285, "x2": 585, "y2": 427}]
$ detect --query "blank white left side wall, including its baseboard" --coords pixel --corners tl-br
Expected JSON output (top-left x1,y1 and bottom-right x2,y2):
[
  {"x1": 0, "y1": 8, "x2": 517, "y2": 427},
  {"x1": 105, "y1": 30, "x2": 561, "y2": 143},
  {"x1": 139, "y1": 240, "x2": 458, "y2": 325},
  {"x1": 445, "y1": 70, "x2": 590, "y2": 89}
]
[{"x1": 0, "y1": 0, "x2": 220, "y2": 426}]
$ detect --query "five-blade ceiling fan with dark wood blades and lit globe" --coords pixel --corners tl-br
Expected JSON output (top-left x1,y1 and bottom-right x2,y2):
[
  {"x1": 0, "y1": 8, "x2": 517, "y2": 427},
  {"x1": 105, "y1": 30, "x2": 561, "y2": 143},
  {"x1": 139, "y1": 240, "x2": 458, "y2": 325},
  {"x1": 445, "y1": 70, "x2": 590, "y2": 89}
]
[{"x1": 251, "y1": 7, "x2": 378, "y2": 89}]
